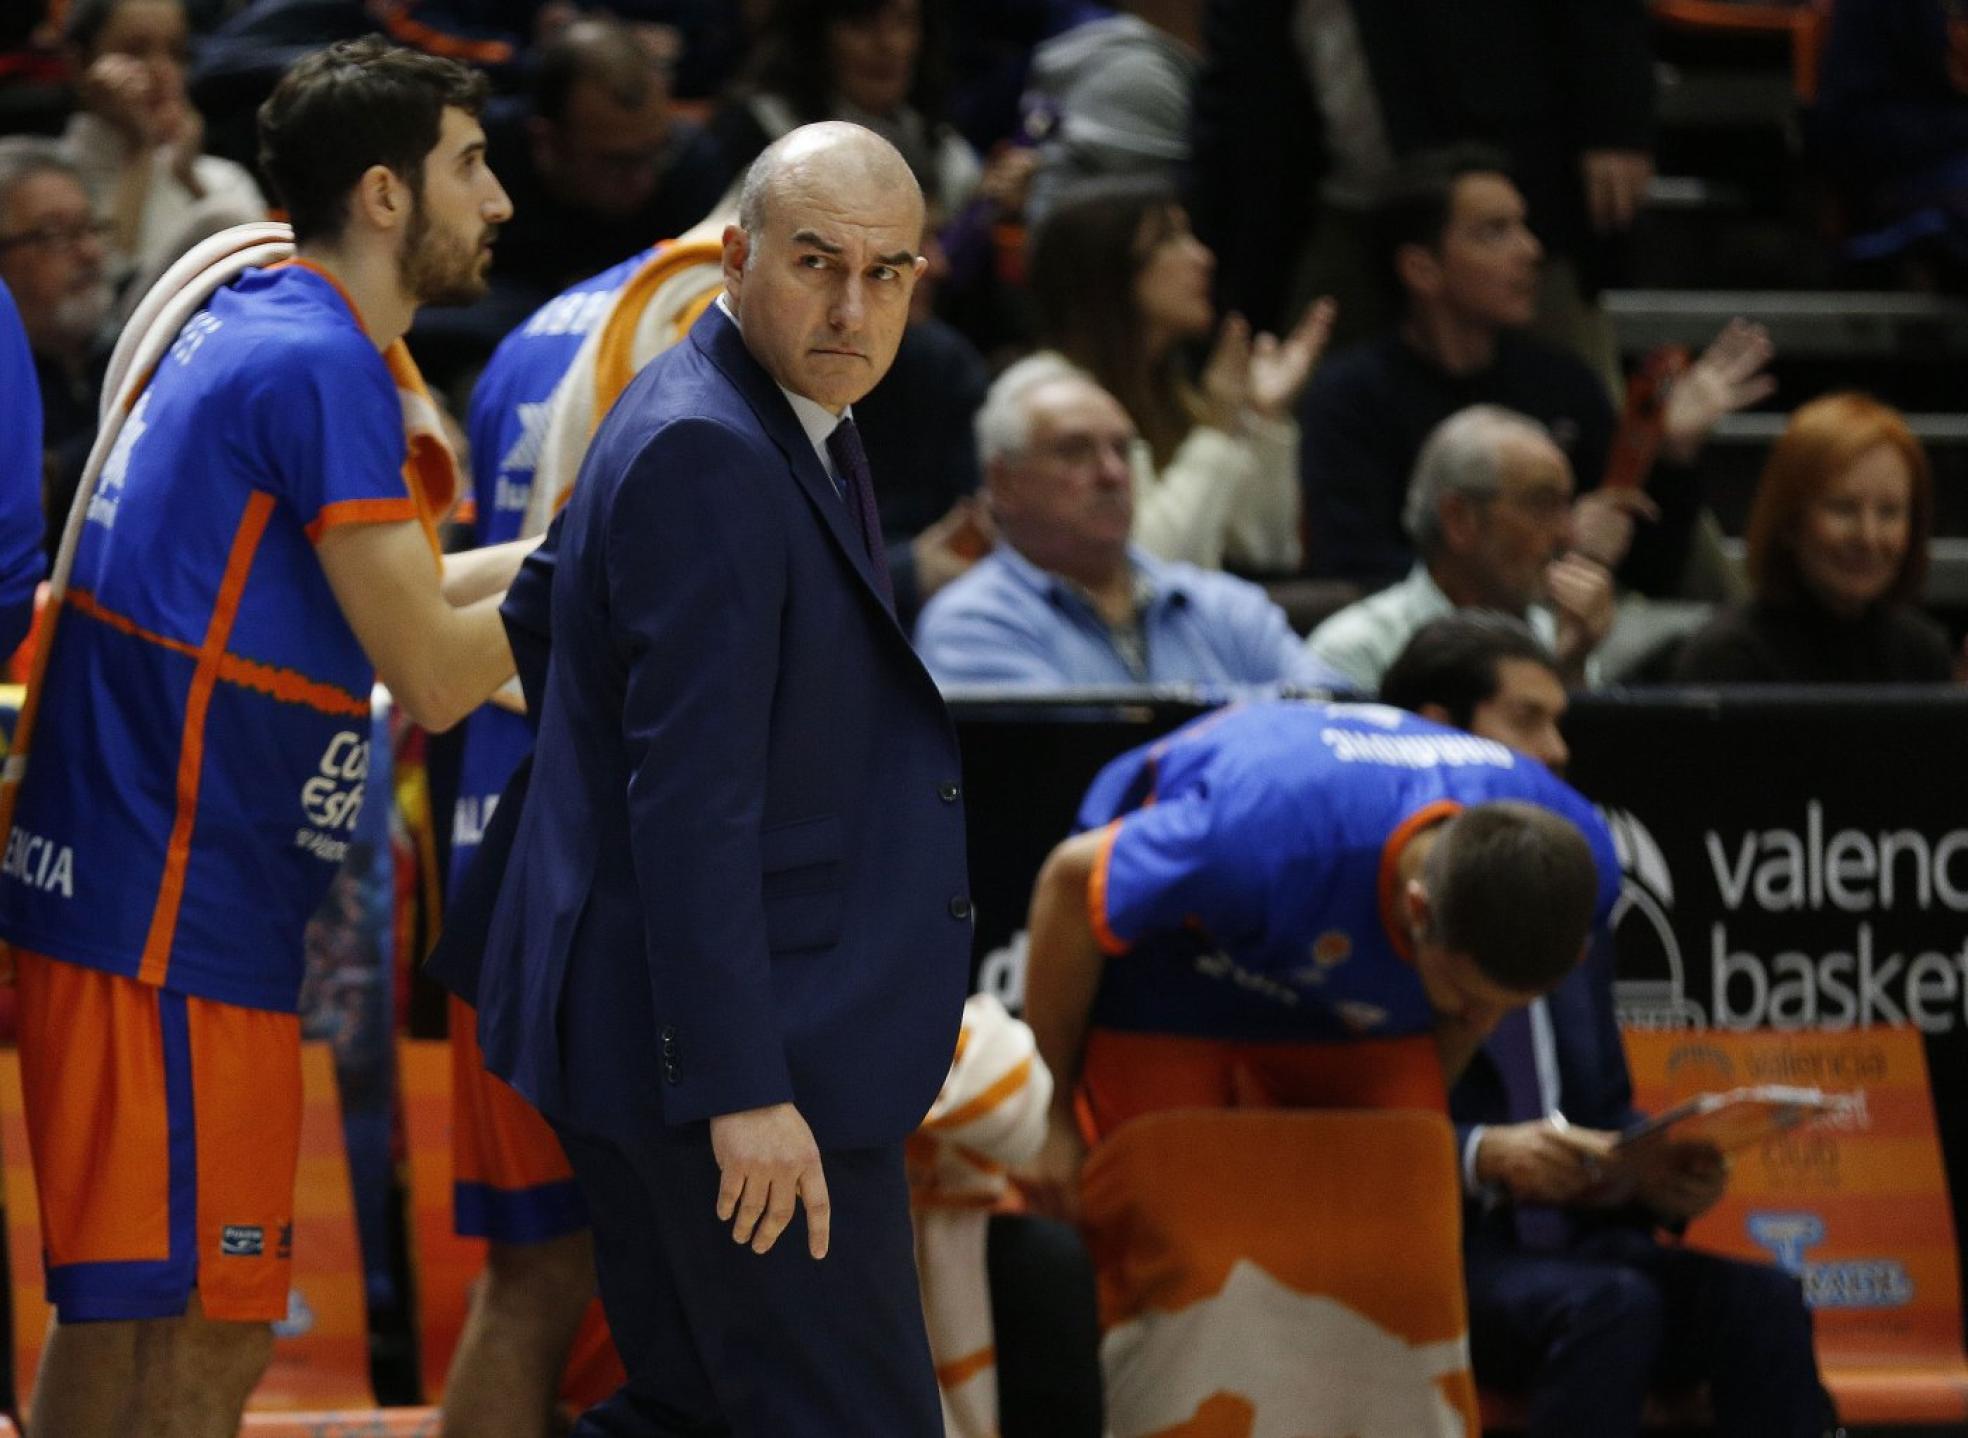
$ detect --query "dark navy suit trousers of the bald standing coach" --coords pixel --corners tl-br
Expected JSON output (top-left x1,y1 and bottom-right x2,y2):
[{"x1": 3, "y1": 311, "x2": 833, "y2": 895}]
[{"x1": 557, "y1": 1123, "x2": 943, "y2": 1438}]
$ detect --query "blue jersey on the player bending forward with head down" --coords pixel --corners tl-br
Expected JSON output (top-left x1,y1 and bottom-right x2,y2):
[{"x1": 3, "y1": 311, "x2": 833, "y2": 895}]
[{"x1": 1080, "y1": 702, "x2": 1620, "y2": 1041}]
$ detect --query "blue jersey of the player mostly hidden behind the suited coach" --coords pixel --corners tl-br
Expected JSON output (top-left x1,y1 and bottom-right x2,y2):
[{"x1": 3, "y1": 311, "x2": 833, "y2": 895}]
[{"x1": 451, "y1": 250, "x2": 653, "y2": 883}]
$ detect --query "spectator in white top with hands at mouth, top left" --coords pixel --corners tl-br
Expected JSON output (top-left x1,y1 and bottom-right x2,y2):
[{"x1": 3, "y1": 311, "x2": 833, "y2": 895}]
[{"x1": 61, "y1": 0, "x2": 268, "y2": 305}]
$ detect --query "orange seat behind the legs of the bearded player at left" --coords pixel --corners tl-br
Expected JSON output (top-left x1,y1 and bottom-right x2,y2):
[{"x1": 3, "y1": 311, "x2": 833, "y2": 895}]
[{"x1": 0, "y1": 1043, "x2": 376, "y2": 1408}]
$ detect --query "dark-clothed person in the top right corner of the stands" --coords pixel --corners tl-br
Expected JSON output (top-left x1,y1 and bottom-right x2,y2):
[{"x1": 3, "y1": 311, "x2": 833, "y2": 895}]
[{"x1": 1807, "y1": 0, "x2": 1968, "y2": 291}]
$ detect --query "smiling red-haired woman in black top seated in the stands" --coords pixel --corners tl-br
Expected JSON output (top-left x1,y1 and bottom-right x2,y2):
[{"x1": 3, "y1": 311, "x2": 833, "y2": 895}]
[{"x1": 1675, "y1": 393, "x2": 1952, "y2": 685}]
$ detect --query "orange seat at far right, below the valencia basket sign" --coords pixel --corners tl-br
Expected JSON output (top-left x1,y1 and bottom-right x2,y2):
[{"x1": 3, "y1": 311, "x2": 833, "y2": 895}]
[{"x1": 1626, "y1": 1027, "x2": 1968, "y2": 1424}]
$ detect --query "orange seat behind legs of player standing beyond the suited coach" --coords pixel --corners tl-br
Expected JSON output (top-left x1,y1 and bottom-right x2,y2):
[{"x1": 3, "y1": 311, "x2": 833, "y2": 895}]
[{"x1": 396, "y1": 1039, "x2": 626, "y2": 1408}]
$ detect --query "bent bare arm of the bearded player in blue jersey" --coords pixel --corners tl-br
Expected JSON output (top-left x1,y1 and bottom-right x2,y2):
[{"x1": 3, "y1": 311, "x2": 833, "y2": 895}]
[{"x1": 315, "y1": 519, "x2": 520, "y2": 730}]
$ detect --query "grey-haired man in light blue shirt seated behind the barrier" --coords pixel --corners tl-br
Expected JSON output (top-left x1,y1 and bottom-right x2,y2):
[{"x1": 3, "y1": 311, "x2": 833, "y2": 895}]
[{"x1": 915, "y1": 354, "x2": 1336, "y2": 689}]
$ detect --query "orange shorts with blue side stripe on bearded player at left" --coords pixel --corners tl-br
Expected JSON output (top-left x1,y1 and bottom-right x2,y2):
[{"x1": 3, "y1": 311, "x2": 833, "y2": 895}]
[{"x1": 14, "y1": 950, "x2": 301, "y2": 1324}]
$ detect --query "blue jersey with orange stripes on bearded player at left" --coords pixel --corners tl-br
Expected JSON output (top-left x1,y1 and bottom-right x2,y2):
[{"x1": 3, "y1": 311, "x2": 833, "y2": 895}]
[{"x1": 0, "y1": 266, "x2": 417, "y2": 1011}]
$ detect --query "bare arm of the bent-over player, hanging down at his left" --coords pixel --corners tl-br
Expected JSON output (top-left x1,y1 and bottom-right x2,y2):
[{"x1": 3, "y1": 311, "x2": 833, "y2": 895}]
[{"x1": 1025, "y1": 830, "x2": 1106, "y2": 1218}]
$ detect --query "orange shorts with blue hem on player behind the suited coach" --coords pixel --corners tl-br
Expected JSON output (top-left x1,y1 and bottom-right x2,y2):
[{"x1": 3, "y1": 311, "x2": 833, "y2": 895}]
[{"x1": 451, "y1": 995, "x2": 588, "y2": 1243}]
